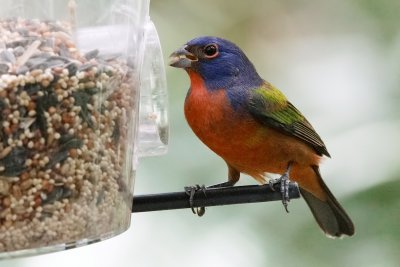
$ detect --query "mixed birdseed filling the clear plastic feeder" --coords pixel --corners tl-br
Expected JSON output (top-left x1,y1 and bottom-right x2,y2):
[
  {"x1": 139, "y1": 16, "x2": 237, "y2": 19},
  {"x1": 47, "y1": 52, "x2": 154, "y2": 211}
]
[{"x1": 0, "y1": 18, "x2": 137, "y2": 252}]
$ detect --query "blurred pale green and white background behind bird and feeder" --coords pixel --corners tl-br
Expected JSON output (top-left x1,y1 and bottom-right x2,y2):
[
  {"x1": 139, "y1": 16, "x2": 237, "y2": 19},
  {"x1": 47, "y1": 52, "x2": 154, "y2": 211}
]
[{"x1": 0, "y1": 0, "x2": 400, "y2": 267}]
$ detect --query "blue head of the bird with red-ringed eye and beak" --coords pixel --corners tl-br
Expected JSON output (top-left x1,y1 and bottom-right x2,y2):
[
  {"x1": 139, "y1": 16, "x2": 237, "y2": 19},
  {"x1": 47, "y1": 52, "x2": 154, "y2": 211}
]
[{"x1": 170, "y1": 36, "x2": 263, "y2": 93}]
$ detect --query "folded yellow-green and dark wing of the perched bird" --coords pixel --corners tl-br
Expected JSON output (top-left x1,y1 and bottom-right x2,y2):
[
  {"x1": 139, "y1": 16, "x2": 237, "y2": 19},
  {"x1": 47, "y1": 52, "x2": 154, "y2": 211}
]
[{"x1": 249, "y1": 83, "x2": 330, "y2": 157}]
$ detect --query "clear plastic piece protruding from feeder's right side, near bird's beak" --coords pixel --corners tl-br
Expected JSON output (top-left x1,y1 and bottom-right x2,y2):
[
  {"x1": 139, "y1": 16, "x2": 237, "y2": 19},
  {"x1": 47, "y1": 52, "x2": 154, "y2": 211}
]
[{"x1": 138, "y1": 17, "x2": 169, "y2": 157}]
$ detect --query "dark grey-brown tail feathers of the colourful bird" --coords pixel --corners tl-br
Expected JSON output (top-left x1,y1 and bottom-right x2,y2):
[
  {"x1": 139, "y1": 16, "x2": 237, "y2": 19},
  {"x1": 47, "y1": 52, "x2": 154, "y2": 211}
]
[{"x1": 300, "y1": 166, "x2": 354, "y2": 237}]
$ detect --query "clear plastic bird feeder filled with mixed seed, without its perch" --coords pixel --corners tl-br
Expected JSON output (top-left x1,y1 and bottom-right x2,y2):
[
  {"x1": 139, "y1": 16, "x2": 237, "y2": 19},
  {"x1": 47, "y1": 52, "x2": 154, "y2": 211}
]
[{"x1": 0, "y1": 0, "x2": 168, "y2": 258}]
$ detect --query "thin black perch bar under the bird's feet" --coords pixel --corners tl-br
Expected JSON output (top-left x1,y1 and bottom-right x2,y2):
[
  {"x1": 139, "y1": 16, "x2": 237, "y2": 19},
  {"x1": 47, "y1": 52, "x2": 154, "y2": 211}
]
[{"x1": 132, "y1": 182, "x2": 300, "y2": 212}]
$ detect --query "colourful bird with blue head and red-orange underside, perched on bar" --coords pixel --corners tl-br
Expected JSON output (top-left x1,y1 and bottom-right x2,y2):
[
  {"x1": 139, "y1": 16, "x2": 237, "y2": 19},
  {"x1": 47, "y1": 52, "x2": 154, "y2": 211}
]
[{"x1": 169, "y1": 36, "x2": 355, "y2": 238}]
